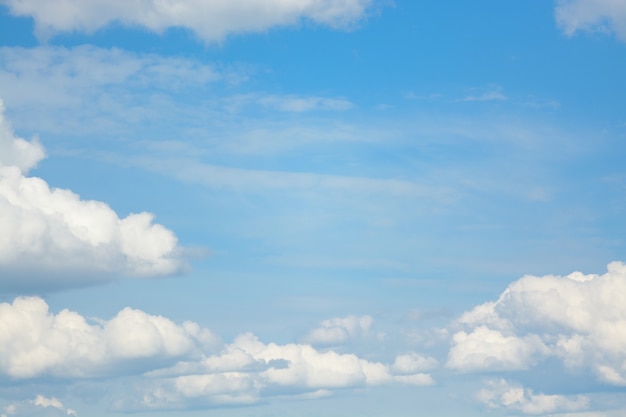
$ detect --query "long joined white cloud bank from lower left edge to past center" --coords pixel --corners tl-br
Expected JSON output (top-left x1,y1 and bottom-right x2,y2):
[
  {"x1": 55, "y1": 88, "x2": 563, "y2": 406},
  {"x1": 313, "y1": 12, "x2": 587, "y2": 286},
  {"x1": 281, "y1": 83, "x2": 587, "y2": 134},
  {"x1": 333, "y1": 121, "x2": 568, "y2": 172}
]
[{"x1": 0, "y1": 297, "x2": 436, "y2": 411}]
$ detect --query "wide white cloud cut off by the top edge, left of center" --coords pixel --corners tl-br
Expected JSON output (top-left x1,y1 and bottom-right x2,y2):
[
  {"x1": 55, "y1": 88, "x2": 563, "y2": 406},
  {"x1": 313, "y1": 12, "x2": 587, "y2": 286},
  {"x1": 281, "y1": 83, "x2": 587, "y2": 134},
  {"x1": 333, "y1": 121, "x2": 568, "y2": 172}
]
[{"x1": 0, "y1": 0, "x2": 371, "y2": 42}]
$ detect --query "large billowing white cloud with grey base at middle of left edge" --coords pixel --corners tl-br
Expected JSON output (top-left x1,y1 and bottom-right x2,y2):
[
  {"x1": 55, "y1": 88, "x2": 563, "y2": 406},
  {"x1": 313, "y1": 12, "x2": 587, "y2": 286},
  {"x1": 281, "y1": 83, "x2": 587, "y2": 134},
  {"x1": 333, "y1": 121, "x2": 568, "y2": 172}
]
[{"x1": 0, "y1": 102, "x2": 182, "y2": 289}]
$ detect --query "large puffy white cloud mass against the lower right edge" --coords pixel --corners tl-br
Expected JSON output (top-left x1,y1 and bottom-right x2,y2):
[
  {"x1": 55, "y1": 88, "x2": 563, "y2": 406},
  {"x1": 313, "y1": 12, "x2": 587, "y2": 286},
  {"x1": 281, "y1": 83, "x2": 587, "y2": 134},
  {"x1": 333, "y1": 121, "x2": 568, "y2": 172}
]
[{"x1": 447, "y1": 262, "x2": 626, "y2": 386}]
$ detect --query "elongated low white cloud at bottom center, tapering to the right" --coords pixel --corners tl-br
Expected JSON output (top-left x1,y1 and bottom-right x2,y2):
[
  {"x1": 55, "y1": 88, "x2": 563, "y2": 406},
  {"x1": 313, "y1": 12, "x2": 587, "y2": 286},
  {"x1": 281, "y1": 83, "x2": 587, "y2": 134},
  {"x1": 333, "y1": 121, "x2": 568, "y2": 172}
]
[{"x1": 134, "y1": 333, "x2": 434, "y2": 408}]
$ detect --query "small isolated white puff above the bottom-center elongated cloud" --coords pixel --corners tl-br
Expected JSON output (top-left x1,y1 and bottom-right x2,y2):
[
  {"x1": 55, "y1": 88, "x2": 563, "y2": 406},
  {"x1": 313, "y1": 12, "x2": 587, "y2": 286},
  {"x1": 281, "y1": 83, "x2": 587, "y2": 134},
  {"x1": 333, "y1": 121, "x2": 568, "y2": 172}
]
[{"x1": 304, "y1": 316, "x2": 374, "y2": 346}]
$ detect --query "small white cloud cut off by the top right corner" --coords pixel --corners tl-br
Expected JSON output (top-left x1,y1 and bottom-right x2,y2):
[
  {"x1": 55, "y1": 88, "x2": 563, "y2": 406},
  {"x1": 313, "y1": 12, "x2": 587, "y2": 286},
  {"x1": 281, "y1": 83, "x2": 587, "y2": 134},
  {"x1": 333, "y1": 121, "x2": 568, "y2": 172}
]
[{"x1": 556, "y1": 0, "x2": 626, "y2": 42}]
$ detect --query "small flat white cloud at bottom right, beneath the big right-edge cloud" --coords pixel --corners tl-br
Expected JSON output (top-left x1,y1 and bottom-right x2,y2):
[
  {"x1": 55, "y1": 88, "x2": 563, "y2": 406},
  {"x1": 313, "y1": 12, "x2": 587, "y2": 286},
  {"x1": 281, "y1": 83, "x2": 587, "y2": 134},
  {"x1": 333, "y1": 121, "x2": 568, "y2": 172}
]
[{"x1": 478, "y1": 379, "x2": 589, "y2": 414}]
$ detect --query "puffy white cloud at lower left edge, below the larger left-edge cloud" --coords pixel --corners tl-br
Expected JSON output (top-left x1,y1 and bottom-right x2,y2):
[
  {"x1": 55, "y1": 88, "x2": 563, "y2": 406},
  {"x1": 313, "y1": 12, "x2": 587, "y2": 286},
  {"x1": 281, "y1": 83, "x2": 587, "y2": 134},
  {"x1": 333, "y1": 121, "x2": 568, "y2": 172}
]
[{"x1": 0, "y1": 297, "x2": 218, "y2": 378}]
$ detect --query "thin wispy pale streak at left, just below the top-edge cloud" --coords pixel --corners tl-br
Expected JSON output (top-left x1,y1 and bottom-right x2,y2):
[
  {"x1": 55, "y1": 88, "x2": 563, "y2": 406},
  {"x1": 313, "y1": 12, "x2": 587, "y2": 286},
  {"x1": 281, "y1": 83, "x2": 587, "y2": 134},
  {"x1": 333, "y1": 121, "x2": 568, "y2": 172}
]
[{"x1": 0, "y1": 45, "x2": 221, "y2": 95}]
